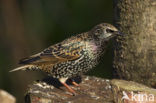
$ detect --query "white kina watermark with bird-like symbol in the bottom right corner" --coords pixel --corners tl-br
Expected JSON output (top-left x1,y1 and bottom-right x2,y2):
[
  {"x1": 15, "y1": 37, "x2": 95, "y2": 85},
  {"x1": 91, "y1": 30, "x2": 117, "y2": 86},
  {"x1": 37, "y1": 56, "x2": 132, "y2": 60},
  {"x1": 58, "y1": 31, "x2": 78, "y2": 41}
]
[{"x1": 122, "y1": 91, "x2": 155, "y2": 102}]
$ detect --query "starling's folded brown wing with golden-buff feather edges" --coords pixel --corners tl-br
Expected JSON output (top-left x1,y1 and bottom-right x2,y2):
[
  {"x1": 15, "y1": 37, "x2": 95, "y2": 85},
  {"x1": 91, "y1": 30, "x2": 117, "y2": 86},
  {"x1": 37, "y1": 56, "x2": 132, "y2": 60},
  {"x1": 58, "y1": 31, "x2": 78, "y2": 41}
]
[{"x1": 19, "y1": 42, "x2": 84, "y2": 64}]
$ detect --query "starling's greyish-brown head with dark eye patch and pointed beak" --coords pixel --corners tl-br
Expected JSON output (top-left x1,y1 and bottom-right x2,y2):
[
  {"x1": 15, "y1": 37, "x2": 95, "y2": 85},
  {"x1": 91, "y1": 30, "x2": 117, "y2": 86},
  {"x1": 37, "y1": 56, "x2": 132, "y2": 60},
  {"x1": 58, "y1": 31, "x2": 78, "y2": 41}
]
[{"x1": 90, "y1": 23, "x2": 123, "y2": 41}]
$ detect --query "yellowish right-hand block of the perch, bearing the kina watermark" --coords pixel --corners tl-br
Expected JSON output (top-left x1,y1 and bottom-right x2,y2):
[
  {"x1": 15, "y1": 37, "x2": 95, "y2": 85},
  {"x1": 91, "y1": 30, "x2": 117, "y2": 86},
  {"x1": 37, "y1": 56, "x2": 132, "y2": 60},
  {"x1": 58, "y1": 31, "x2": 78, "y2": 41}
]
[{"x1": 111, "y1": 79, "x2": 156, "y2": 103}]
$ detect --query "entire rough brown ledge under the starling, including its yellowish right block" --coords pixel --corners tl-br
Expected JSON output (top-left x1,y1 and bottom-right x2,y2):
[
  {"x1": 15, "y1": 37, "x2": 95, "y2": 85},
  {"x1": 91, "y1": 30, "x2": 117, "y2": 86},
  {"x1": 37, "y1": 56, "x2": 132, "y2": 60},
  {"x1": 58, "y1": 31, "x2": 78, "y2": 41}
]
[{"x1": 25, "y1": 76, "x2": 156, "y2": 103}]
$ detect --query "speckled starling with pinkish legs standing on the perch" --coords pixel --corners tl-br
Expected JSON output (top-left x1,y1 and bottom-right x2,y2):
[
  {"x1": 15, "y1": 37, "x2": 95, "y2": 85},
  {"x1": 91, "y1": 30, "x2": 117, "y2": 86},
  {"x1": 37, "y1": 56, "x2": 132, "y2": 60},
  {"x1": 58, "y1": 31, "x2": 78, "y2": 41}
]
[{"x1": 10, "y1": 23, "x2": 123, "y2": 94}]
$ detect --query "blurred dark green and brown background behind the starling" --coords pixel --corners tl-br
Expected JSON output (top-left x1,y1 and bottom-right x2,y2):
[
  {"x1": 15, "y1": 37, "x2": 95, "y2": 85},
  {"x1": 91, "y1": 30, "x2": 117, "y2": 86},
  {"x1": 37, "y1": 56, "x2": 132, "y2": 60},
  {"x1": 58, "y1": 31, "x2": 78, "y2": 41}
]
[{"x1": 0, "y1": 0, "x2": 113, "y2": 103}]
